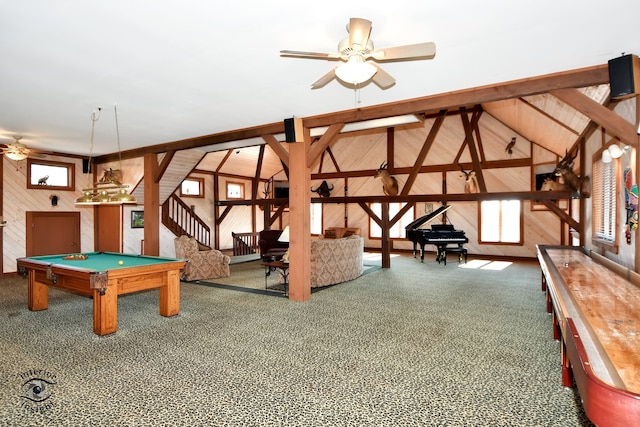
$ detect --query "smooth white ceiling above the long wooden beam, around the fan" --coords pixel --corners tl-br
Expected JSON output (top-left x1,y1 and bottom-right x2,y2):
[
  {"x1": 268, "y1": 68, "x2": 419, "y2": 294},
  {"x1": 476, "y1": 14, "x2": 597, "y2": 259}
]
[{"x1": 0, "y1": 0, "x2": 640, "y2": 155}]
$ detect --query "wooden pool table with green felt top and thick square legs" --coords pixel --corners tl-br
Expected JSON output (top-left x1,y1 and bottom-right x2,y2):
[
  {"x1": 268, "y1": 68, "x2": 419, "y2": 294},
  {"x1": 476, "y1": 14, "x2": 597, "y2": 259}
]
[{"x1": 17, "y1": 252, "x2": 185, "y2": 335}]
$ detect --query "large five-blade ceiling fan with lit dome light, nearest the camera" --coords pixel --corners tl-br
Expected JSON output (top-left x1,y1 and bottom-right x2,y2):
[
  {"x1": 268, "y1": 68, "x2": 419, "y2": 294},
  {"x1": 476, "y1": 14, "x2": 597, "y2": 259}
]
[{"x1": 280, "y1": 18, "x2": 436, "y2": 89}]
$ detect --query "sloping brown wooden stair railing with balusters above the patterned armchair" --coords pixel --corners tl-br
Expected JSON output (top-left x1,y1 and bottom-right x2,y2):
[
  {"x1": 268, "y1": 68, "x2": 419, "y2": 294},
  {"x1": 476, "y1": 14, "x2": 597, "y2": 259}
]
[{"x1": 162, "y1": 194, "x2": 211, "y2": 248}]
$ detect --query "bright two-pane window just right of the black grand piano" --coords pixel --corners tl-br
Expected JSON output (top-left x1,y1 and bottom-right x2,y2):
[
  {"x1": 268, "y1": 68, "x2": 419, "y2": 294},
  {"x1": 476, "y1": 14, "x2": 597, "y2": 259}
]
[{"x1": 479, "y1": 200, "x2": 523, "y2": 245}]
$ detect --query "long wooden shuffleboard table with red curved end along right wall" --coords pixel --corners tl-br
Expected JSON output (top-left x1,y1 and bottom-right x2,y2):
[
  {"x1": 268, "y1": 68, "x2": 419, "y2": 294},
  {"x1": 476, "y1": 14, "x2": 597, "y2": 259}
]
[{"x1": 537, "y1": 245, "x2": 640, "y2": 427}]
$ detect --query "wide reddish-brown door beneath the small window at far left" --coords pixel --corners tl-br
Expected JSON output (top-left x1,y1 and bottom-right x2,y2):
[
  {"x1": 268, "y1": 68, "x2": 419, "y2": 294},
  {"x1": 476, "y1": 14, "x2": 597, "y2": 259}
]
[{"x1": 26, "y1": 211, "x2": 82, "y2": 256}]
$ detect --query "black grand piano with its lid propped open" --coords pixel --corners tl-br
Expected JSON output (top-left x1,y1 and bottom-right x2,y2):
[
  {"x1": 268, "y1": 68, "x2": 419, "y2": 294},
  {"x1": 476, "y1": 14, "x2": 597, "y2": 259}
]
[{"x1": 405, "y1": 205, "x2": 469, "y2": 263}]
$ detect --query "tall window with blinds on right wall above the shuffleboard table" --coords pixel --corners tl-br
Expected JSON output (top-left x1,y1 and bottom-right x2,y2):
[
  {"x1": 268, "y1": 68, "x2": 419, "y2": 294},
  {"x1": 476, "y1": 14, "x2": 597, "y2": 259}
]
[{"x1": 591, "y1": 159, "x2": 618, "y2": 244}]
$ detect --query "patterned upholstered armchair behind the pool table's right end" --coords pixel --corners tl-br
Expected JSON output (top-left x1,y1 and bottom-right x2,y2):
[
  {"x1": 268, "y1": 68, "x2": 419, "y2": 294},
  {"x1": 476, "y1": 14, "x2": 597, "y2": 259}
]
[{"x1": 174, "y1": 235, "x2": 231, "y2": 281}]
